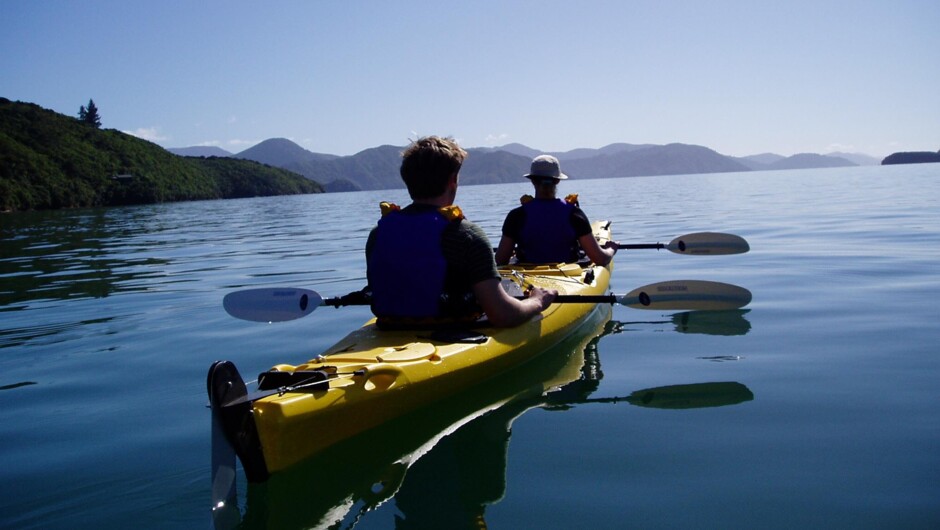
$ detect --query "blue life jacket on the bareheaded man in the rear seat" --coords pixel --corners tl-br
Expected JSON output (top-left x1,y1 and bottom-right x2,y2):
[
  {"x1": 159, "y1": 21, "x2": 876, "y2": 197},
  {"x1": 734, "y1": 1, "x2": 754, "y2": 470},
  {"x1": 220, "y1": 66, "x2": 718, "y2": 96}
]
[{"x1": 368, "y1": 210, "x2": 451, "y2": 318}]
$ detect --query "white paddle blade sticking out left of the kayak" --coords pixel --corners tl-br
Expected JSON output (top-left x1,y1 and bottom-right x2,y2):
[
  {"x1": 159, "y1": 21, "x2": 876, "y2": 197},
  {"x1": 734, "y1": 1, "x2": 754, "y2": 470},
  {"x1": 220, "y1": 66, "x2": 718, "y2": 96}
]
[{"x1": 222, "y1": 287, "x2": 323, "y2": 322}]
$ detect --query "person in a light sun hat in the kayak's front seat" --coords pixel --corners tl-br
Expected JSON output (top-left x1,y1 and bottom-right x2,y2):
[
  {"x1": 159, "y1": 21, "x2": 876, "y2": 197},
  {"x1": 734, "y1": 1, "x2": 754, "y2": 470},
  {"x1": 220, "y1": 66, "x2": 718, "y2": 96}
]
[{"x1": 496, "y1": 155, "x2": 617, "y2": 265}]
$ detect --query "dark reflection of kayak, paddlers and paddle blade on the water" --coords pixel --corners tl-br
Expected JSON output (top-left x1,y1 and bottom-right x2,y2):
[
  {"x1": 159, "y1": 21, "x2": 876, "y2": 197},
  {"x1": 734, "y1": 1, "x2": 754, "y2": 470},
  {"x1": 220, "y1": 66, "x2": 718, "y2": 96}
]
[{"x1": 242, "y1": 306, "x2": 754, "y2": 529}]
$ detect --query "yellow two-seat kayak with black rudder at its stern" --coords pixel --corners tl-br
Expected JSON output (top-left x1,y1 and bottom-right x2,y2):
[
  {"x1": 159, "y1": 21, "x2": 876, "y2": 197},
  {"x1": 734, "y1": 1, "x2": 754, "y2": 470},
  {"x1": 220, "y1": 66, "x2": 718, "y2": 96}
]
[{"x1": 208, "y1": 221, "x2": 612, "y2": 482}]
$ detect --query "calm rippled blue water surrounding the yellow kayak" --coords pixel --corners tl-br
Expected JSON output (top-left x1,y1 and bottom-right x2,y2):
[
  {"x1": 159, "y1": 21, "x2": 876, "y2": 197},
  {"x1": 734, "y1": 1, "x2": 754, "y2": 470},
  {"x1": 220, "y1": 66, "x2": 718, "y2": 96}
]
[{"x1": 0, "y1": 164, "x2": 940, "y2": 529}]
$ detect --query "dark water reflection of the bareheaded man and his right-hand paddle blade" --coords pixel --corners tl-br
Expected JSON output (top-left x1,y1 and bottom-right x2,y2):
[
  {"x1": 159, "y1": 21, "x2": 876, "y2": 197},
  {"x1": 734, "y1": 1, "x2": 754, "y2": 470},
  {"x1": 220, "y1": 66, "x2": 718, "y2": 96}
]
[{"x1": 386, "y1": 321, "x2": 754, "y2": 530}]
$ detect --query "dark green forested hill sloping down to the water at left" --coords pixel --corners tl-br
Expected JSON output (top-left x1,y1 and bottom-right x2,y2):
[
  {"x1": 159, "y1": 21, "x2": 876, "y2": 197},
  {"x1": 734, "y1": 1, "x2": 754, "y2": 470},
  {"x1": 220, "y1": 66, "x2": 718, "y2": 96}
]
[{"x1": 0, "y1": 98, "x2": 323, "y2": 211}]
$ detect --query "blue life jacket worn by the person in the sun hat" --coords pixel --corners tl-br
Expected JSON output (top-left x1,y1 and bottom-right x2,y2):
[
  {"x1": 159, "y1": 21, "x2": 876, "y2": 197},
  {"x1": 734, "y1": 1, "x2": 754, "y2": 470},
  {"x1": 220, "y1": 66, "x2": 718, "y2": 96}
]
[{"x1": 516, "y1": 199, "x2": 578, "y2": 263}]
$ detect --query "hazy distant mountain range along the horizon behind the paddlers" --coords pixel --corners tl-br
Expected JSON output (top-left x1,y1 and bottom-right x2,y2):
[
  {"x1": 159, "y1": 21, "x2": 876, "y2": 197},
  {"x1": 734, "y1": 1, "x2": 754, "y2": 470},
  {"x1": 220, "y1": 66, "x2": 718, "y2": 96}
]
[{"x1": 168, "y1": 138, "x2": 880, "y2": 191}]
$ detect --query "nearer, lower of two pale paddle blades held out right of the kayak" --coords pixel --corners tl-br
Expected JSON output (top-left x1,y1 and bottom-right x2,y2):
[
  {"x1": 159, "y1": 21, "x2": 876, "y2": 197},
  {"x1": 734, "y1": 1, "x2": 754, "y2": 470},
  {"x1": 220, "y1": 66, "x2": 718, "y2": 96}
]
[{"x1": 620, "y1": 280, "x2": 751, "y2": 311}]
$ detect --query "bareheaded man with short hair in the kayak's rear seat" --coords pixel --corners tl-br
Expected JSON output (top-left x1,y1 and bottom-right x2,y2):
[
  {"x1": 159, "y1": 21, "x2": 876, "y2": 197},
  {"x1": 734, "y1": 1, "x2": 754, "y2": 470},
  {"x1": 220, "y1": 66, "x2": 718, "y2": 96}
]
[{"x1": 366, "y1": 136, "x2": 557, "y2": 327}]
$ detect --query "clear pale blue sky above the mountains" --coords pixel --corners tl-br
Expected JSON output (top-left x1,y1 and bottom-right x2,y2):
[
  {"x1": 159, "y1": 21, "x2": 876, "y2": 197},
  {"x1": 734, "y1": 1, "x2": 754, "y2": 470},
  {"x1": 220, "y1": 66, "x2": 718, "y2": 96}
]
[{"x1": 0, "y1": 0, "x2": 940, "y2": 157}]
